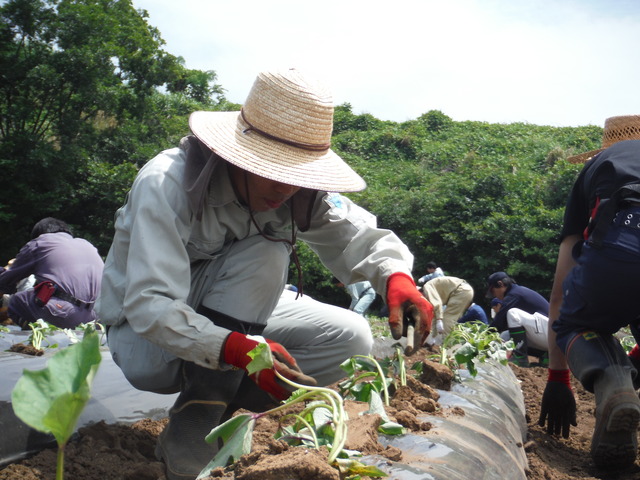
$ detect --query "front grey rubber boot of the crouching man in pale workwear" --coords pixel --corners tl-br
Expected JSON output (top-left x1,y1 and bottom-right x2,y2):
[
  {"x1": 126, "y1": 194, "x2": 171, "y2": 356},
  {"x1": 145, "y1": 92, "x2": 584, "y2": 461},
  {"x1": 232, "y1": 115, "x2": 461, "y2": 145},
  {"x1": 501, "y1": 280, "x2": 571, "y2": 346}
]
[{"x1": 155, "y1": 362, "x2": 245, "y2": 480}]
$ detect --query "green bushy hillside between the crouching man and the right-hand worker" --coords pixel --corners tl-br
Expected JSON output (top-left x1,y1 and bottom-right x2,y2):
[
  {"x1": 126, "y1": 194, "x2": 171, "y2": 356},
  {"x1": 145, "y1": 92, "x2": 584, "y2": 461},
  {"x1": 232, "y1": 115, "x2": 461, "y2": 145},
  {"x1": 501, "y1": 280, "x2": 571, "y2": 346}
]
[{"x1": 320, "y1": 104, "x2": 602, "y2": 305}]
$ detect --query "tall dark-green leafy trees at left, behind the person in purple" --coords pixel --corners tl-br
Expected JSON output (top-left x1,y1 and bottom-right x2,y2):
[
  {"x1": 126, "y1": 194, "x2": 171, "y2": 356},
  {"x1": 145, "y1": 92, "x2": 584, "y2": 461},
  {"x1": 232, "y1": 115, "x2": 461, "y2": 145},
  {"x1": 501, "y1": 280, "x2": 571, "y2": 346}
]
[{"x1": 0, "y1": 0, "x2": 225, "y2": 258}]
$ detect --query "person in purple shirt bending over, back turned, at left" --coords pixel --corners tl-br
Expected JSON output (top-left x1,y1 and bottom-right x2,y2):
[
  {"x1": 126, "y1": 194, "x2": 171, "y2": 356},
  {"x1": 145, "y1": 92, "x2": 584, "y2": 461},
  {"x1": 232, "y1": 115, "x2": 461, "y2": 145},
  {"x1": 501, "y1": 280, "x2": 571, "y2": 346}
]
[{"x1": 0, "y1": 217, "x2": 104, "y2": 329}]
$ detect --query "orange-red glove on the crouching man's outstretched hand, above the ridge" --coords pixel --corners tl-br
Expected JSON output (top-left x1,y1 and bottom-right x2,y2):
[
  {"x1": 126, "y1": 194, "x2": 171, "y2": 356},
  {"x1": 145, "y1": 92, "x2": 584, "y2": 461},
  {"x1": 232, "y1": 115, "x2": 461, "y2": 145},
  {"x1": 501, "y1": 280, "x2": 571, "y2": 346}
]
[{"x1": 387, "y1": 272, "x2": 433, "y2": 348}]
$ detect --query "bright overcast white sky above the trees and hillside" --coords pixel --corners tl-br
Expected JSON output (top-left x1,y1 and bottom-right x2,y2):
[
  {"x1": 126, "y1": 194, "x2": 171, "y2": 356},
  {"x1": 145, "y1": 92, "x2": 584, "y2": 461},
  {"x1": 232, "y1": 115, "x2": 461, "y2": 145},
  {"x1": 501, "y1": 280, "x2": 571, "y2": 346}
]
[{"x1": 133, "y1": 0, "x2": 640, "y2": 126}]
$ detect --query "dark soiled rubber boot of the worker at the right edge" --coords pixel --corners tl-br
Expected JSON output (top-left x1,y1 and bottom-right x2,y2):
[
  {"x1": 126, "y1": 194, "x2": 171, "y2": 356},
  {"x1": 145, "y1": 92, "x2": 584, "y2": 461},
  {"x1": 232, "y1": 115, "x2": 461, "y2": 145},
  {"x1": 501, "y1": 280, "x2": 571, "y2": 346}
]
[{"x1": 567, "y1": 332, "x2": 640, "y2": 468}]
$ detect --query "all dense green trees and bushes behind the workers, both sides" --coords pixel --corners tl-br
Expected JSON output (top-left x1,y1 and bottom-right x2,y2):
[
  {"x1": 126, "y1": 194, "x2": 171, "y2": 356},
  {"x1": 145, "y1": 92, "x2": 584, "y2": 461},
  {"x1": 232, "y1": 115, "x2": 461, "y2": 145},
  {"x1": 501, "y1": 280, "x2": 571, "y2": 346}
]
[{"x1": 0, "y1": 0, "x2": 602, "y2": 308}]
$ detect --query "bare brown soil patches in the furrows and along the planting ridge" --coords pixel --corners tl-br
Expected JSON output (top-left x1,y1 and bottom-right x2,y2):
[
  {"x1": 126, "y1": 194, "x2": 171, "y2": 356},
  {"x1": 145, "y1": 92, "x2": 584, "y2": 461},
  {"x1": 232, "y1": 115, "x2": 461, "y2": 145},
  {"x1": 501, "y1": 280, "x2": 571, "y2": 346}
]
[{"x1": 0, "y1": 350, "x2": 640, "y2": 480}]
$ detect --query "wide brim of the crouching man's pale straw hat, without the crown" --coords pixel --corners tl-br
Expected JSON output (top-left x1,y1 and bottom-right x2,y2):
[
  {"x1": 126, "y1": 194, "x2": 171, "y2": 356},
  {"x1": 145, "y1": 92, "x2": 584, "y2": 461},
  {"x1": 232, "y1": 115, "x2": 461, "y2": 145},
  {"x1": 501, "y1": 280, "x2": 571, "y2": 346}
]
[{"x1": 189, "y1": 111, "x2": 366, "y2": 192}]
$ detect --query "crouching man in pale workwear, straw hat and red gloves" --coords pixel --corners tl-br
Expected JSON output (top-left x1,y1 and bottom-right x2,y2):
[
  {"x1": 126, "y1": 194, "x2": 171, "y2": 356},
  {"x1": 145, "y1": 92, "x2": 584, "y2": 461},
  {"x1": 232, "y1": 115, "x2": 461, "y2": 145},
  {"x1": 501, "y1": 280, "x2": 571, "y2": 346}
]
[{"x1": 98, "y1": 69, "x2": 433, "y2": 480}]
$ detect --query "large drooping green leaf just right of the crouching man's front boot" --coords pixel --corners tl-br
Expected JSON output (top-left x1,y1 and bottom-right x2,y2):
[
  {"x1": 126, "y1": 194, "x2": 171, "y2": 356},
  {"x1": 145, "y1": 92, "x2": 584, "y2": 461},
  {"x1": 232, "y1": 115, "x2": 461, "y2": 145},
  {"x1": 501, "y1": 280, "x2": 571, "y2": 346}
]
[{"x1": 202, "y1": 413, "x2": 256, "y2": 480}]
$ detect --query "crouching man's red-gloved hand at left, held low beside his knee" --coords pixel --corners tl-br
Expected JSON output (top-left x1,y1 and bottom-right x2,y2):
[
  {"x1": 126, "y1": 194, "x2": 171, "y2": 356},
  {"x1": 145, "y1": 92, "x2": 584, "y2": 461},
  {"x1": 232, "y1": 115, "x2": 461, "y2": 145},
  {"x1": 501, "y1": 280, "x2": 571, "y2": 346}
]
[{"x1": 223, "y1": 332, "x2": 318, "y2": 400}]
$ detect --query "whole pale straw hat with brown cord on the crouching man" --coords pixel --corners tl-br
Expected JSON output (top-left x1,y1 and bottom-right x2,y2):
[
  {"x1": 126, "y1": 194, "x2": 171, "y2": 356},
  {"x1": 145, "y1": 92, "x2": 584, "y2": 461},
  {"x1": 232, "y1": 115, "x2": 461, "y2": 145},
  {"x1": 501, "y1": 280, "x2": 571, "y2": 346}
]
[{"x1": 189, "y1": 69, "x2": 366, "y2": 192}]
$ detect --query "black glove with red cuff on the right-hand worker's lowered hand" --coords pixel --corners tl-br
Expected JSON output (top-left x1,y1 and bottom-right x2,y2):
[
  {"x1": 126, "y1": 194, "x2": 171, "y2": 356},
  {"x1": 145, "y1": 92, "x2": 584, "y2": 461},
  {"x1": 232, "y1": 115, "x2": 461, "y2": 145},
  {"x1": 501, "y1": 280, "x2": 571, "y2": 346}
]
[{"x1": 538, "y1": 369, "x2": 578, "y2": 438}]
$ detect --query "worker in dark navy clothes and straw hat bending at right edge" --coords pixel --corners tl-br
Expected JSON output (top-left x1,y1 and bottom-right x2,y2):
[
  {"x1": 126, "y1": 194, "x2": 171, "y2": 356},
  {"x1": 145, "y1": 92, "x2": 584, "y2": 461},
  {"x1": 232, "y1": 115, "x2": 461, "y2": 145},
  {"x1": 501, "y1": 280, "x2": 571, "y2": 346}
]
[{"x1": 539, "y1": 115, "x2": 640, "y2": 468}]
